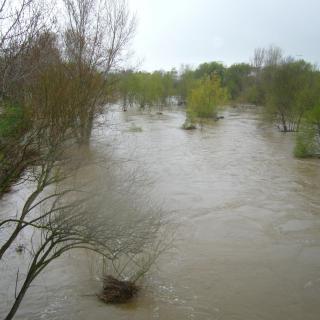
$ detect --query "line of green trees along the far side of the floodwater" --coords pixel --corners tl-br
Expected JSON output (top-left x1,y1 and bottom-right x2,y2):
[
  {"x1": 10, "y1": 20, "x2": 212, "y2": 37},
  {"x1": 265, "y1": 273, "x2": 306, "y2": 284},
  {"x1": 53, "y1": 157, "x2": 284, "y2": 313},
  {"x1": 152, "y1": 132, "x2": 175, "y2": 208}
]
[{"x1": 117, "y1": 46, "x2": 320, "y2": 157}]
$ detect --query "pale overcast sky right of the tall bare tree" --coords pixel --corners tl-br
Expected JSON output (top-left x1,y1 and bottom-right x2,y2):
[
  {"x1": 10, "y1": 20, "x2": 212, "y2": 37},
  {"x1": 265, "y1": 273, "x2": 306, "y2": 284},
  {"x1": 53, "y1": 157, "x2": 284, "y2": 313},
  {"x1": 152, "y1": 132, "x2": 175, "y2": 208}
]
[{"x1": 128, "y1": 0, "x2": 320, "y2": 71}]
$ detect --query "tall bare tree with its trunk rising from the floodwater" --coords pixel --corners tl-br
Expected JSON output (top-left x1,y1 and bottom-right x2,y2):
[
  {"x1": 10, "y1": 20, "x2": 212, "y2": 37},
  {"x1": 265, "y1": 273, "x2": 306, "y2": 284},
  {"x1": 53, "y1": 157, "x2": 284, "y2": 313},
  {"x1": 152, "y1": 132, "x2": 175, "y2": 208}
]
[{"x1": 63, "y1": 0, "x2": 135, "y2": 144}]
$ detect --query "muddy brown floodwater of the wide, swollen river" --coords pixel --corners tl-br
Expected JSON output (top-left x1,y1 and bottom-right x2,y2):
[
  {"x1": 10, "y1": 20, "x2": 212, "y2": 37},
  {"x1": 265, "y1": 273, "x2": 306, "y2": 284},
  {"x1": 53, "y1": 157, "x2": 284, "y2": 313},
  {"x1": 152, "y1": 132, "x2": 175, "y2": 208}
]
[{"x1": 0, "y1": 108, "x2": 320, "y2": 320}]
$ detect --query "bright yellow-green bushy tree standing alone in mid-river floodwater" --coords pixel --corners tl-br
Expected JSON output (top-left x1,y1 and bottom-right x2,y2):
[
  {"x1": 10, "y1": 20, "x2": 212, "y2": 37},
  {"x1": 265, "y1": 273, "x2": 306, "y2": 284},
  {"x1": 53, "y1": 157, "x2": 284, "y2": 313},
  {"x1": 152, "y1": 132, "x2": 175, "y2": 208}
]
[{"x1": 187, "y1": 76, "x2": 228, "y2": 121}]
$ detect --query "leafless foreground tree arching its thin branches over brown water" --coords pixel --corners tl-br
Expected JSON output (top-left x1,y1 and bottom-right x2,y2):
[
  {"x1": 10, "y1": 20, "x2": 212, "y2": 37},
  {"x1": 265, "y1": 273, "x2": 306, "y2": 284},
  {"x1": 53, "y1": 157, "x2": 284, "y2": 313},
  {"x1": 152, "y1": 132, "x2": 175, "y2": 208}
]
[{"x1": 0, "y1": 154, "x2": 168, "y2": 319}]
